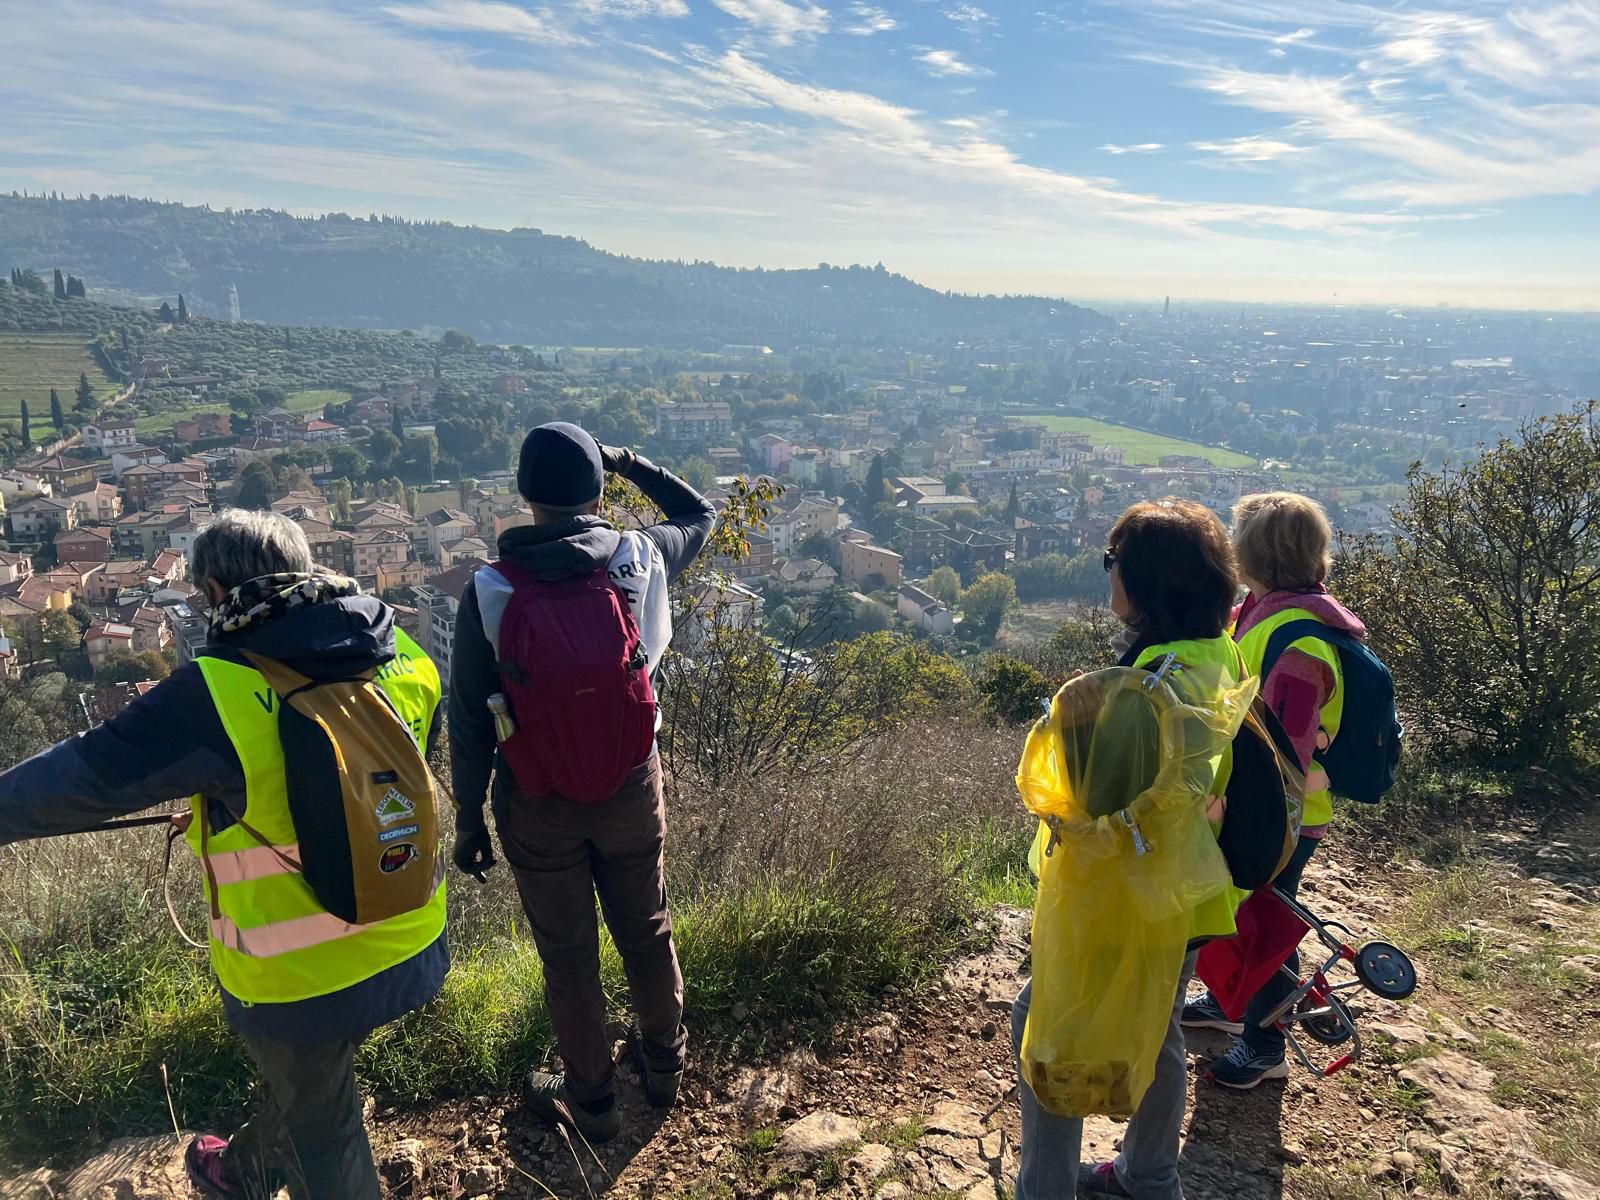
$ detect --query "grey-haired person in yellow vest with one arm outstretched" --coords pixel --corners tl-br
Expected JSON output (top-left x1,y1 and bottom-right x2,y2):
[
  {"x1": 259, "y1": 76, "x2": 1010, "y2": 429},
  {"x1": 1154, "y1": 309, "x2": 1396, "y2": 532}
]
[{"x1": 0, "y1": 510, "x2": 450, "y2": 1200}]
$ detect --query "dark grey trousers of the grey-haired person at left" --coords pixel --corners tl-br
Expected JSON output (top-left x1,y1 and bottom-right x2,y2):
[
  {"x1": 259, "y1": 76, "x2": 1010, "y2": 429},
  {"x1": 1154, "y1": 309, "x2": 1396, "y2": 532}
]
[{"x1": 224, "y1": 1038, "x2": 382, "y2": 1200}]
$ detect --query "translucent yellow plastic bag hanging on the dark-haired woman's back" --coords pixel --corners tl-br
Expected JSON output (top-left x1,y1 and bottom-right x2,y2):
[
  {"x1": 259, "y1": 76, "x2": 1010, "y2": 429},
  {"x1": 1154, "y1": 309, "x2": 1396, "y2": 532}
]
[{"x1": 1016, "y1": 667, "x2": 1256, "y2": 1117}]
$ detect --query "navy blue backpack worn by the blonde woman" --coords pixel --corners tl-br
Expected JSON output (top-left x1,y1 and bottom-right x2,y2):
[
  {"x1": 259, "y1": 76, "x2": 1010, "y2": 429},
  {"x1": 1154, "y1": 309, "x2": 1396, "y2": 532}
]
[{"x1": 1261, "y1": 619, "x2": 1405, "y2": 805}]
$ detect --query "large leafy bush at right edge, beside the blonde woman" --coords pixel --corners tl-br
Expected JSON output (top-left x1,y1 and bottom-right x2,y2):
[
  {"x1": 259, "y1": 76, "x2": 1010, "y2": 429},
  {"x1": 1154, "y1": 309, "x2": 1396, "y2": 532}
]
[{"x1": 1333, "y1": 403, "x2": 1600, "y2": 765}]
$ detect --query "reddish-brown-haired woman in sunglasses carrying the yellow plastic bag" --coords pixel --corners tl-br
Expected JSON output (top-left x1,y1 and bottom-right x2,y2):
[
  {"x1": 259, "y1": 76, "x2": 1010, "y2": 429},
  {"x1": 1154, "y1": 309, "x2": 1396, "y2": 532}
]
[{"x1": 1011, "y1": 499, "x2": 1248, "y2": 1200}]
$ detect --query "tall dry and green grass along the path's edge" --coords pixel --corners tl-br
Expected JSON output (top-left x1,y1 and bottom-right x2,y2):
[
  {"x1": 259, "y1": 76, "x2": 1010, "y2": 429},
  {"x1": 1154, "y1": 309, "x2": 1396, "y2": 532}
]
[{"x1": 0, "y1": 720, "x2": 1029, "y2": 1162}]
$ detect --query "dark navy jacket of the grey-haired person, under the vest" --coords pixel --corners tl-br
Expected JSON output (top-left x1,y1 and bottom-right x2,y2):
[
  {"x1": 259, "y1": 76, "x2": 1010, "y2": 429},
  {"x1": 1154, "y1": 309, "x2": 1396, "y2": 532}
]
[{"x1": 0, "y1": 595, "x2": 450, "y2": 1042}]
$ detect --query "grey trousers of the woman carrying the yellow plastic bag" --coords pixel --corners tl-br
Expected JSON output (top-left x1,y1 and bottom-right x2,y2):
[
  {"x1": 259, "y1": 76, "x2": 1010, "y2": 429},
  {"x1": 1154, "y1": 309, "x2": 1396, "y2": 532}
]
[{"x1": 1011, "y1": 954, "x2": 1197, "y2": 1200}]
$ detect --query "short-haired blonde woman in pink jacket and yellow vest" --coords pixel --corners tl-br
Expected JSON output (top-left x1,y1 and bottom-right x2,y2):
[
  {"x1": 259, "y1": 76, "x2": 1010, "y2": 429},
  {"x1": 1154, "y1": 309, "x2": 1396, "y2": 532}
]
[{"x1": 1182, "y1": 491, "x2": 1366, "y2": 1088}]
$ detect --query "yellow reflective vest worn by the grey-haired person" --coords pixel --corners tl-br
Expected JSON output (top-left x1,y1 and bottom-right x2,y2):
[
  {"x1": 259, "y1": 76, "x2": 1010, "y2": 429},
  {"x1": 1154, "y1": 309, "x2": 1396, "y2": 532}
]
[{"x1": 186, "y1": 630, "x2": 445, "y2": 1003}]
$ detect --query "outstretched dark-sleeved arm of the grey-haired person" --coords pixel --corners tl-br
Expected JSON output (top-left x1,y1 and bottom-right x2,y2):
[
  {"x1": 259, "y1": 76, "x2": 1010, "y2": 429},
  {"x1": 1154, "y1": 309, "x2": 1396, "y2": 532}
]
[{"x1": 0, "y1": 664, "x2": 243, "y2": 845}]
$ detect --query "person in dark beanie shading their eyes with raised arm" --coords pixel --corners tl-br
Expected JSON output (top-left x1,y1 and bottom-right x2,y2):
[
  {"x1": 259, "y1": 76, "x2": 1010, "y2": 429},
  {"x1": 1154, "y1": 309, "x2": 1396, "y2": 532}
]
[{"x1": 450, "y1": 422, "x2": 717, "y2": 1142}]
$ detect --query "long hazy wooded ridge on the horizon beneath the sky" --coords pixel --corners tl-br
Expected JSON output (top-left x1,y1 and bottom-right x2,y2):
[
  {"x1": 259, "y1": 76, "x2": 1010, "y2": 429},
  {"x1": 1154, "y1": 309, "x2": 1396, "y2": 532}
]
[{"x1": 0, "y1": 195, "x2": 1107, "y2": 349}]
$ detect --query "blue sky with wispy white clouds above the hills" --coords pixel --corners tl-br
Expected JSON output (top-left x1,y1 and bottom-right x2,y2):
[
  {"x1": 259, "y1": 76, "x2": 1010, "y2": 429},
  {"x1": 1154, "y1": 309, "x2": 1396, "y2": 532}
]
[{"x1": 0, "y1": 0, "x2": 1600, "y2": 309}]
